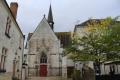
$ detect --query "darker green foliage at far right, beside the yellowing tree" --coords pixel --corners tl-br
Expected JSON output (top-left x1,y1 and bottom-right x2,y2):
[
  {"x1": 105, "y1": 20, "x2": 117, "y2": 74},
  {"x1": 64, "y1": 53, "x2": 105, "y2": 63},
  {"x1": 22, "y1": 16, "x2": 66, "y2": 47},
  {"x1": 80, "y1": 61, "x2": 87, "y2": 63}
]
[{"x1": 103, "y1": 24, "x2": 120, "y2": 60}]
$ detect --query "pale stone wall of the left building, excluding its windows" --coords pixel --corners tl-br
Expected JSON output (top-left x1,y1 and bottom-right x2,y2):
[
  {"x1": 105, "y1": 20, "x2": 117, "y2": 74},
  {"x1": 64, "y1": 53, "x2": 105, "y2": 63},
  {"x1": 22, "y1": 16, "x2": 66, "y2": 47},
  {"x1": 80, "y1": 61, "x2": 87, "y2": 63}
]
[{"x1": 0, "y1": 0, "x2": 24, "y2": 79}]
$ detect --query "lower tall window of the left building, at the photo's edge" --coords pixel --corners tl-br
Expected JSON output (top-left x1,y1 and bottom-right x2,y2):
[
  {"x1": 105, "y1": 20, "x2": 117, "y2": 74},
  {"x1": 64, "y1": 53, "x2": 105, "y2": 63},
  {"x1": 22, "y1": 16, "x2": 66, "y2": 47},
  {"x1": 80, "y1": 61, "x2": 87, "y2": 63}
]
[{"x1": 0, "y1": 47, "x2": 7, "y2": 70}]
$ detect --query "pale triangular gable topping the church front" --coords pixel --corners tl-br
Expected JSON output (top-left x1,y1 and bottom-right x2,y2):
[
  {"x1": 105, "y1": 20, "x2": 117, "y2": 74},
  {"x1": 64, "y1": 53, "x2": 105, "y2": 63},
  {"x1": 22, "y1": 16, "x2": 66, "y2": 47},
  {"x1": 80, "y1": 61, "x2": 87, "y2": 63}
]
[{"x1": 30, "y1": 17, "x2": 58, "y2": 41}]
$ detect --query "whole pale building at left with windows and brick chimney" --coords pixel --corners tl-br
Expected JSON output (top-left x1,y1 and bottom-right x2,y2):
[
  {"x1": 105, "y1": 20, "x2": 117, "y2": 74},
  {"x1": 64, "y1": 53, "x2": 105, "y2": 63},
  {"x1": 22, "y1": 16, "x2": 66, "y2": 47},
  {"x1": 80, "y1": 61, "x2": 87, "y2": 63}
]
[{"x1": 0, "y1": 0, "x2": 24, "y2": 79}]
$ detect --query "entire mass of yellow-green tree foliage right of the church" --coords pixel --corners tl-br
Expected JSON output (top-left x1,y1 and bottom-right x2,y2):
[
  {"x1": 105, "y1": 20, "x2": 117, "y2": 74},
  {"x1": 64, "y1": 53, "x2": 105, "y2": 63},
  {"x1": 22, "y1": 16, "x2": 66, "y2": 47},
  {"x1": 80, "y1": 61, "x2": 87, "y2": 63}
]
[{"x1": 66, "y1": 18, "x2": 120, "y2": 61}]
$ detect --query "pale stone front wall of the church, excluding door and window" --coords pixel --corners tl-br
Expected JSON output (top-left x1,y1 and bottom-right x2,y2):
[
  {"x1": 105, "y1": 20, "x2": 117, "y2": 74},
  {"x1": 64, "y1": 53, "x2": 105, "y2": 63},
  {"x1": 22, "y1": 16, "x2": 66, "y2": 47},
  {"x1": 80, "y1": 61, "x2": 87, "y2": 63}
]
[{"x1": 28, "y1": 18, "x2": 61, "y2": 76}]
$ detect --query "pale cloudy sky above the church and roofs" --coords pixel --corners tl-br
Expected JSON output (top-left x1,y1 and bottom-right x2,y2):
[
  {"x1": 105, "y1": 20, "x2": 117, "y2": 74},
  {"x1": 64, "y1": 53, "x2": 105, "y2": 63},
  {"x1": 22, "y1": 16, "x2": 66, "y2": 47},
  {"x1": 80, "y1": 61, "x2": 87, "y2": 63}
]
[{"x1": 7, "y1": 0, "x2": 120, "y2": 35}]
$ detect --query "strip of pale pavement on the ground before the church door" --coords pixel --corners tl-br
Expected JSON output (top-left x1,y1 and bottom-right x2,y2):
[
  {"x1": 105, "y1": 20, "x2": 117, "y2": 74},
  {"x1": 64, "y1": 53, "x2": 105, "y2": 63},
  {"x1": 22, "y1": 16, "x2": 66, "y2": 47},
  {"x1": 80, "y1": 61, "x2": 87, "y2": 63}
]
[{"x1": 28, "y1": 76, "x2": 72, "y2": 80}]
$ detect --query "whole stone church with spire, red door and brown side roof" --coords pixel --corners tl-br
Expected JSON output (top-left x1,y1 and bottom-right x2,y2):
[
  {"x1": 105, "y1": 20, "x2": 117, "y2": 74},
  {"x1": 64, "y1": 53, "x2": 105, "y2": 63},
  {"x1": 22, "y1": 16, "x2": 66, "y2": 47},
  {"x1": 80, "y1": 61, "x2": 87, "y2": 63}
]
[{"x1": 26, "y1": 5, "x2": 71, "y2": 77}]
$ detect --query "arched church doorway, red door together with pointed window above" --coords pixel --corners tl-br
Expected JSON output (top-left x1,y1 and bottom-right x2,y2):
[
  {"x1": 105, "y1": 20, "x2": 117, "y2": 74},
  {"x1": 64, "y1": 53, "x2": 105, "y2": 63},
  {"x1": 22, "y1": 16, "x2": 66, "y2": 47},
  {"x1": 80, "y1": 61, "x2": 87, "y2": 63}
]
[{"x1": 40, "y1": 53, "x2": 47, "y2": 77}]
